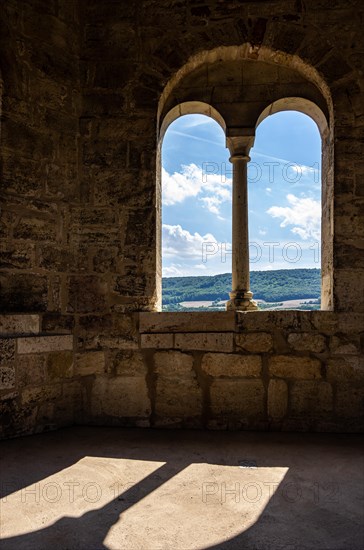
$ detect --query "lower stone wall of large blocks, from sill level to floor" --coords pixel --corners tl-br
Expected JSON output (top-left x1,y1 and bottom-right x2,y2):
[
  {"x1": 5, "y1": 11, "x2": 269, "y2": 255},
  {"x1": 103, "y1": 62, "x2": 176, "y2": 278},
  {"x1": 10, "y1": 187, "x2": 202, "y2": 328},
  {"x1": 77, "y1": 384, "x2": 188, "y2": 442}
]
[{"x1": 0, "y1": 311, "x2": 364, "y2": 437}]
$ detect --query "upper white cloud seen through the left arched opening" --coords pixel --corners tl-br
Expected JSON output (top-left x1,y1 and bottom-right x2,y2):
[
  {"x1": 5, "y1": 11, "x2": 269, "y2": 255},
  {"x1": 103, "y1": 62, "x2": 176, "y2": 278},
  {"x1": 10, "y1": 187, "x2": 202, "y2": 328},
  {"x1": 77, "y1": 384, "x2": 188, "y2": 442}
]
[{"x1": 162, "y1": 164, "x2": 231, "y2": 216}]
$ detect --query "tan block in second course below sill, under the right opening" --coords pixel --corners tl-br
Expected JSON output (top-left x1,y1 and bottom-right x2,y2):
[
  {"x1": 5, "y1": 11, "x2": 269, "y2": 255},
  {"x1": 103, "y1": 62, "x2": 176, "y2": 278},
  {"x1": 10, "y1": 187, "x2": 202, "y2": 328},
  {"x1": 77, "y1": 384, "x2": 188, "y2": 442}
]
[{"x1": 269, "y1": 355, "x2": 321, "y2": 380}]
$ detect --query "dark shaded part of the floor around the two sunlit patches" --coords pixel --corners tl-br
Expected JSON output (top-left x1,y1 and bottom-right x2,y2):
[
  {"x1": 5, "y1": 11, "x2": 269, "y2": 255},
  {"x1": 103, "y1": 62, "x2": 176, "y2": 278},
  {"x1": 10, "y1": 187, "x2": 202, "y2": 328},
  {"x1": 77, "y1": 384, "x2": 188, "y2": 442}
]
[{"x1": 0, "y1": 428, "x2": 364, "y2": 550}]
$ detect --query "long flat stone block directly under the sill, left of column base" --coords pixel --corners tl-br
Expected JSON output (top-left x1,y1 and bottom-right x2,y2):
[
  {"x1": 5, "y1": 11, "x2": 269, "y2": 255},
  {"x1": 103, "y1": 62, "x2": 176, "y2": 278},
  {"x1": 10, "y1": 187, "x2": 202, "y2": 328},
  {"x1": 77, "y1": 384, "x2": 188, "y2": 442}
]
[{"x1": 174, "y1": 332, "x2": 234, "y2": 352}]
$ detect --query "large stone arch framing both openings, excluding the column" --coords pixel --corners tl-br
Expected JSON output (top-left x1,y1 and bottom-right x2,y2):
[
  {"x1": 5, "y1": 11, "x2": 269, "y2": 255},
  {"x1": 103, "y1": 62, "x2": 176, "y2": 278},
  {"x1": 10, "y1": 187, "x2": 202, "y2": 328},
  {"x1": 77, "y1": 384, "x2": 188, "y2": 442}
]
[{"x1": 156, "y1": 43, "x2": 334, "y2": 310}]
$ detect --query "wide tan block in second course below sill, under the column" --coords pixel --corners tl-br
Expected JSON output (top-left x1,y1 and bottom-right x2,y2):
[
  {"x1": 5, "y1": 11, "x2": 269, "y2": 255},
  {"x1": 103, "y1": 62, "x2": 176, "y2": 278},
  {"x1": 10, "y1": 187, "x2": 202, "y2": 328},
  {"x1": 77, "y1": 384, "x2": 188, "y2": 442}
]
[{"x1": 201, "y1": 353, "x2": 262, "y2": 378}]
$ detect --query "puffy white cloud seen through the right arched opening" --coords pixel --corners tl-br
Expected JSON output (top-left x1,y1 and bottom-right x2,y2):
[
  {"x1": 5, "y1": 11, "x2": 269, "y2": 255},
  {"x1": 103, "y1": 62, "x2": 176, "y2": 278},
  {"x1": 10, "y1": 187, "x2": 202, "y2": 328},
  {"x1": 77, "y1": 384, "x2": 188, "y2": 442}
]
[{"x1": 267, "y1": 194, "x2": 321, "y2": 240}]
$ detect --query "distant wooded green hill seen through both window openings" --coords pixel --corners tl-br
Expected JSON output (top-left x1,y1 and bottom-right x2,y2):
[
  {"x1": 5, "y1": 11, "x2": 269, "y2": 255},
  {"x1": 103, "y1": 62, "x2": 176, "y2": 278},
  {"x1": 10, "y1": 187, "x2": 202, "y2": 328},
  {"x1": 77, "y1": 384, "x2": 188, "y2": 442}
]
[{"x1": 162, "y1": 269, "x2": 321, "y2": 305}]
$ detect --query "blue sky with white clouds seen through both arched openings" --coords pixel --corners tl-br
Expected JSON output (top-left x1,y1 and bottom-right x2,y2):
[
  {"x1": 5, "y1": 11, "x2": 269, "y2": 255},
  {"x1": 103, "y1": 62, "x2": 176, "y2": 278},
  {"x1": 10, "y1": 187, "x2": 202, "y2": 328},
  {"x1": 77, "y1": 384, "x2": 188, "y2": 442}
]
[{"x1": 162, "y1": 111, "x2": 321, "y2": 277}]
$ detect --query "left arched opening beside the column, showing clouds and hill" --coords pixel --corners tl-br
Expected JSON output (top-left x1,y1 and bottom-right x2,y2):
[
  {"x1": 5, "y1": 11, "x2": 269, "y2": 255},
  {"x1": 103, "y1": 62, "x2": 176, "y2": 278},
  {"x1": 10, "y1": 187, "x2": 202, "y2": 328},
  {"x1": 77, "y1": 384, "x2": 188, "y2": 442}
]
[{"x1": 161, "y1": 114, "x2": 231, "y2": 311}]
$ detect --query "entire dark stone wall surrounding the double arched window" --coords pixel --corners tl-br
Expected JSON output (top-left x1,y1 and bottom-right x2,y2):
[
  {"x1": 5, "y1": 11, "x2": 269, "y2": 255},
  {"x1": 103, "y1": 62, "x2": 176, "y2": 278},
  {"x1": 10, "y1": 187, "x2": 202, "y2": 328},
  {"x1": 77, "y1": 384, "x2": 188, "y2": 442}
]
[{"x1": 0, "y1": 0, "x2": 364, "y2": 436}]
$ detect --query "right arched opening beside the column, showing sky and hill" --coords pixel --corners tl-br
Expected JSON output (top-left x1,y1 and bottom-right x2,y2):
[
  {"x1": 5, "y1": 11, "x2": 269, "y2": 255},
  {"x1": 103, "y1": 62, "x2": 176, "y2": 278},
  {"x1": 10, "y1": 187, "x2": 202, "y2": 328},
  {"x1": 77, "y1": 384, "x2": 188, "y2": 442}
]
[{"x1": 248, "y1": 110, "x2": 321, "y2": 309}]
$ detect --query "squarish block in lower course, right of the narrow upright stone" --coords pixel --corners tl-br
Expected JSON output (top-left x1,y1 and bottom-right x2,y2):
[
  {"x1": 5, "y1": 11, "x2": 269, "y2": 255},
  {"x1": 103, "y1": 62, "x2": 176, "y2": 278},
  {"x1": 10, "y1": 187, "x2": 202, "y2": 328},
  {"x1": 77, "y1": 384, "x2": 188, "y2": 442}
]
[{"x1": 290, "y1": 380, "x2": 333, "y2": 417}]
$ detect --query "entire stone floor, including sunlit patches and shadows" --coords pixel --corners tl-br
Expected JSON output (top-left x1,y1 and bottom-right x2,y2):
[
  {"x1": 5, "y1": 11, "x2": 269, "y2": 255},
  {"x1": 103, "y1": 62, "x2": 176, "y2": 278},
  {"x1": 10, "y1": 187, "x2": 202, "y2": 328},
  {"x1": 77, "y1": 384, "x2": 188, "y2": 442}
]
[{"x1": 0, "y1": 427, "x2": 364, "y2": 550}]
